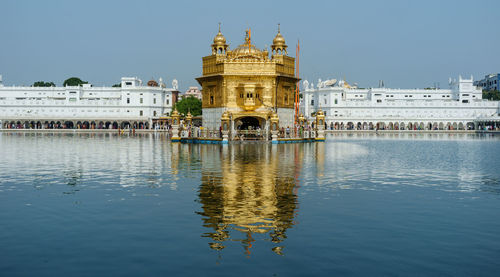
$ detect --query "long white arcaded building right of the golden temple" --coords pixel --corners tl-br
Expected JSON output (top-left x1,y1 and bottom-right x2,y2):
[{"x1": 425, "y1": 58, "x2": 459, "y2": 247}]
[{"x1": 300, "y1": 77, "x2": 500, "y2": 130}]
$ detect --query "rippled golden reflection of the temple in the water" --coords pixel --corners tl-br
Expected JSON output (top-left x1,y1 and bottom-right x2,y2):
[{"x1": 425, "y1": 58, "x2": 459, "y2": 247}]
[{"x1": 190, "y1": 144, "x2": 310, "y2": 255}]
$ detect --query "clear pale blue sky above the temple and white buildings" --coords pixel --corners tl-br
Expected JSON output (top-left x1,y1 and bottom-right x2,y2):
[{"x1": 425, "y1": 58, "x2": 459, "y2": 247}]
[{"x1": 0, "y1": 0, "x2": 500, "y2": 91}]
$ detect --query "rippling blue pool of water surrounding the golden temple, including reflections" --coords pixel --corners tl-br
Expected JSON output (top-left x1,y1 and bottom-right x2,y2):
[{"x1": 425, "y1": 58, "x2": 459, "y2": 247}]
[{"x1": 0, "y1": 133, "x2": 500, "y2": 276}]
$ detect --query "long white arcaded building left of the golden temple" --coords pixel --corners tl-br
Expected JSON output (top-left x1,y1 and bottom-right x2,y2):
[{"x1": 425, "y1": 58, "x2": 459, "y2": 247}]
[{"x1": 0, "y1": 77, "x2": 178, "y2": 129}]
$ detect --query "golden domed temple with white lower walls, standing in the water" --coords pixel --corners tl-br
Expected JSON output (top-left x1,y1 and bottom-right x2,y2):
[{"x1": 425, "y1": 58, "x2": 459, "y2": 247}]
[{"x1": 196, "y1": 26, "x2": 299, "y2": 135}]
